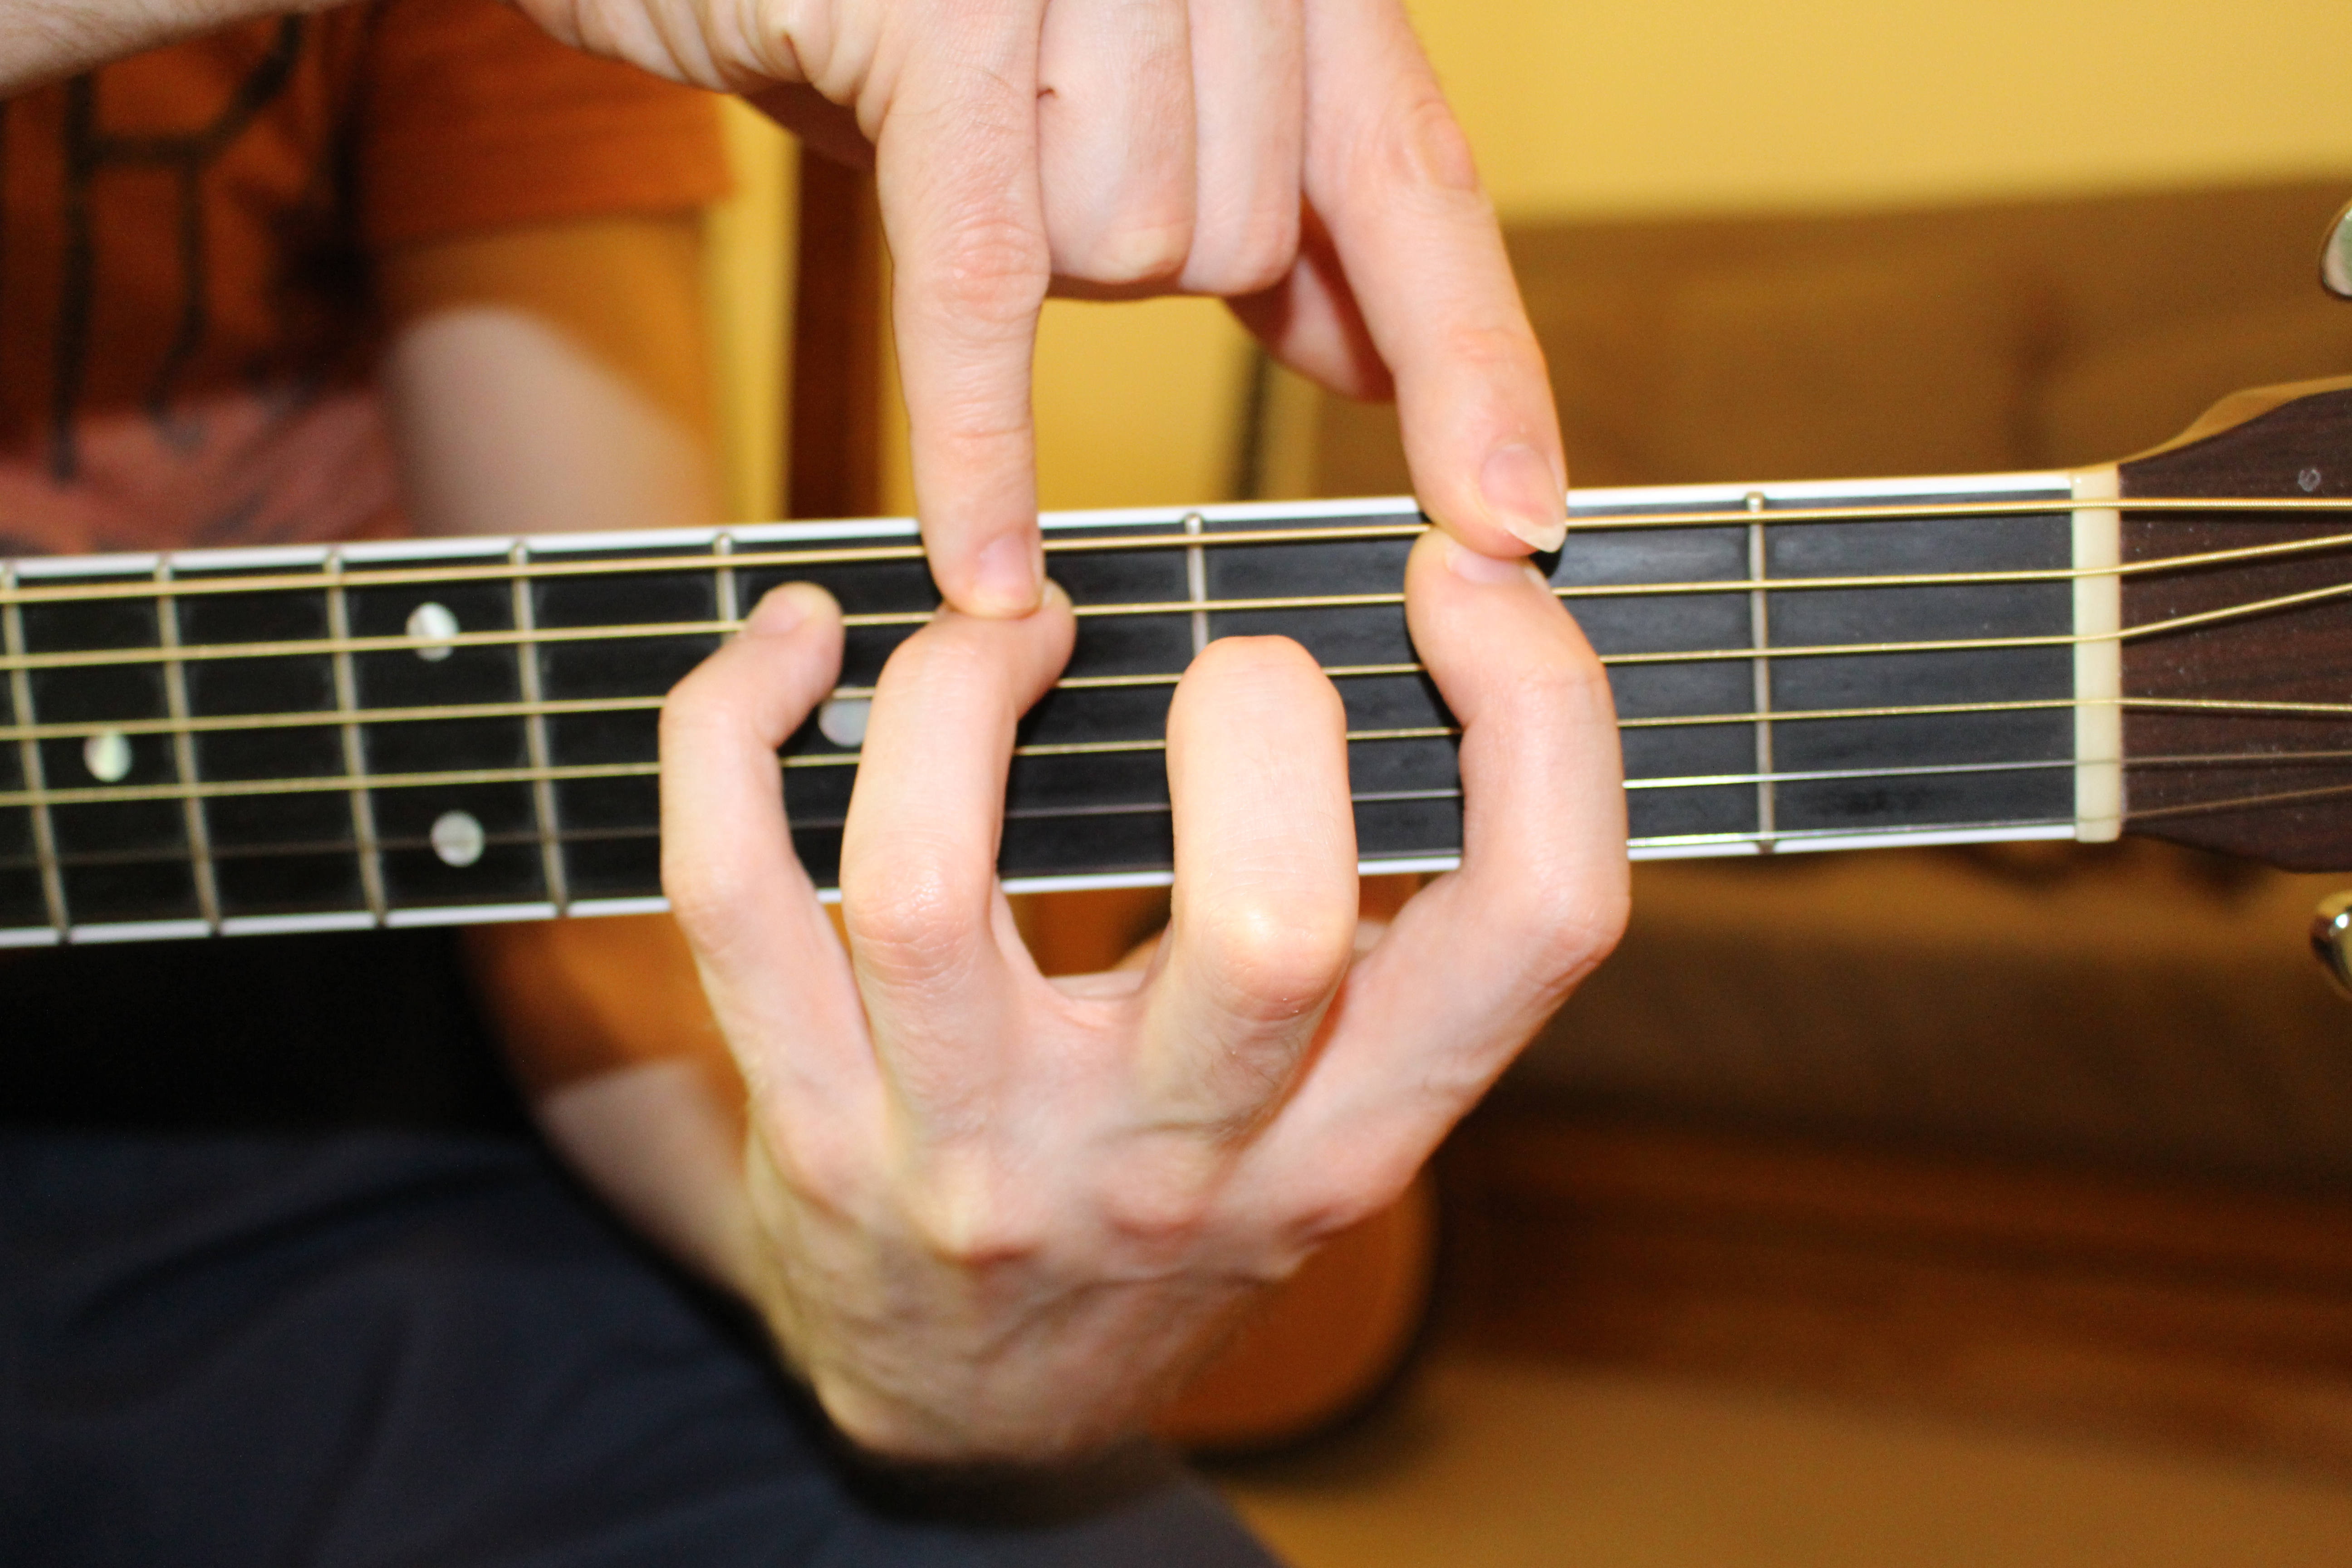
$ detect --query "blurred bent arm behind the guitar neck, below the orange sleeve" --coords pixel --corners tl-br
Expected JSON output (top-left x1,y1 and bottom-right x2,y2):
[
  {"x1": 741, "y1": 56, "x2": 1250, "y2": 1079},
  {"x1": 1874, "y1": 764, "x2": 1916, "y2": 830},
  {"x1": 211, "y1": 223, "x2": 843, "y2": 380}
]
[{"x1": 379, "y1": 214, "x2": 750, "y2": 1291}]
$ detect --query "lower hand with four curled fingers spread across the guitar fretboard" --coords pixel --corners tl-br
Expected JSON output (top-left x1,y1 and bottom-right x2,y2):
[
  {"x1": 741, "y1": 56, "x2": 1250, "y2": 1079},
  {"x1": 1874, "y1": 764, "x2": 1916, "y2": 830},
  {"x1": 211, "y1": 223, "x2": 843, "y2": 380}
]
[{"x1": 661, "y1": 534, "x2": 1625, "y2": 1460}]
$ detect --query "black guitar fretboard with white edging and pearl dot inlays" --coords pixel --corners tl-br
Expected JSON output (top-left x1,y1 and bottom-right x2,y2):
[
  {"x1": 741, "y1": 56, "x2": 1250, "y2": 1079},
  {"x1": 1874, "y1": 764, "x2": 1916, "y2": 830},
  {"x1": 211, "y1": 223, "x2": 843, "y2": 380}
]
[{"x1": 0, "y1": 475, "x2": 2112, "y2": 945}]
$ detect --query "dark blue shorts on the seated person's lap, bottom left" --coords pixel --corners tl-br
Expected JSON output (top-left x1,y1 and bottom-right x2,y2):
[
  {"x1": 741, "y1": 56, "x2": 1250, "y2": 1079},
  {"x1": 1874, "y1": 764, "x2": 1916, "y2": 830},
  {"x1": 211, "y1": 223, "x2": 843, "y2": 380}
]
[{"x1": 0, "y1": 931, "x2": 1270, "y2": 1568}]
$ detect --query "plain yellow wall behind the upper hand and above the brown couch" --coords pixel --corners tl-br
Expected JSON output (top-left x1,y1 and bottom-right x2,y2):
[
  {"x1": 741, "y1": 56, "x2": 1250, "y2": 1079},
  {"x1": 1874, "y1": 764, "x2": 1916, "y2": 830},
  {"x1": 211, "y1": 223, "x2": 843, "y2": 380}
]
[{"x1": 851, "y1": 0, "x2": 2352, "y2": 522}]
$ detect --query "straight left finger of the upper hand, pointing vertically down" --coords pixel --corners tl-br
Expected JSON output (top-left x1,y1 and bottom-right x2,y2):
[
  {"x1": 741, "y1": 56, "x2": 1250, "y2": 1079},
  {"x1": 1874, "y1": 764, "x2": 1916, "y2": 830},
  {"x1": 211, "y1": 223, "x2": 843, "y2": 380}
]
[{"x1": 879, "y1": 0, "x2": 1051, "y2": 618}]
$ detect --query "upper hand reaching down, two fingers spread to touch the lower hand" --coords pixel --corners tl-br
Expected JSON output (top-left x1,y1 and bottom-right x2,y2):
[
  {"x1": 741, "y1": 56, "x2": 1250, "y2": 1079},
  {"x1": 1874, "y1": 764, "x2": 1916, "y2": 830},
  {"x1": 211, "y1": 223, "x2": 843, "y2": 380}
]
[{"x1": 517, "y1": 0, "x2": 1567, "y2": 616}]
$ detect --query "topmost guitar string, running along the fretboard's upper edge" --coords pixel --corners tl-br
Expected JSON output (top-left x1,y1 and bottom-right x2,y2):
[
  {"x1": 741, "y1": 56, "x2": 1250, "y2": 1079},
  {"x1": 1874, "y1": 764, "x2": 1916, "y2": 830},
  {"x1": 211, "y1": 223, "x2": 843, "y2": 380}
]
[{"x1": 0, "y1": 496, "x2": 2352, "y2": 604}]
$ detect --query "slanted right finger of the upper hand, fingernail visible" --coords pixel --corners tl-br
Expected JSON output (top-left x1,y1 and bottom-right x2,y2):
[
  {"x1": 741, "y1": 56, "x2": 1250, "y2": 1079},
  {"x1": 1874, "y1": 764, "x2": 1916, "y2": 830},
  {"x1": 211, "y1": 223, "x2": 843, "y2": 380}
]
[{"x1": 1305, "y1": 0, "x2": 1569, "y2": 555}]
